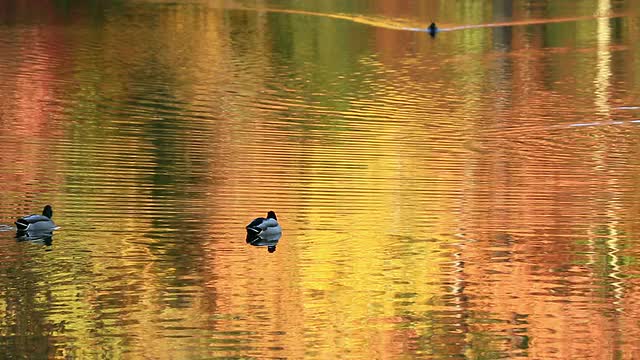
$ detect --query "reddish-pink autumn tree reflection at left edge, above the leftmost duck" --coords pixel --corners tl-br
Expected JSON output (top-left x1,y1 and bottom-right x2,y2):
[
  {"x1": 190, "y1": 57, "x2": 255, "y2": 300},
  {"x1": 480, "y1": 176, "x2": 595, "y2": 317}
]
[{"x1": 0, "y1": 6, "x2": 70, "y2": 216}]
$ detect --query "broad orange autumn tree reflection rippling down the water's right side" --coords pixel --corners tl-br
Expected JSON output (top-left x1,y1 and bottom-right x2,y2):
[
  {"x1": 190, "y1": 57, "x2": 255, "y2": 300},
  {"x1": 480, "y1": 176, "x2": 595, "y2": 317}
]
[{"x1": 360, "y1": 2, "x2": 636, "y2": 358}]
